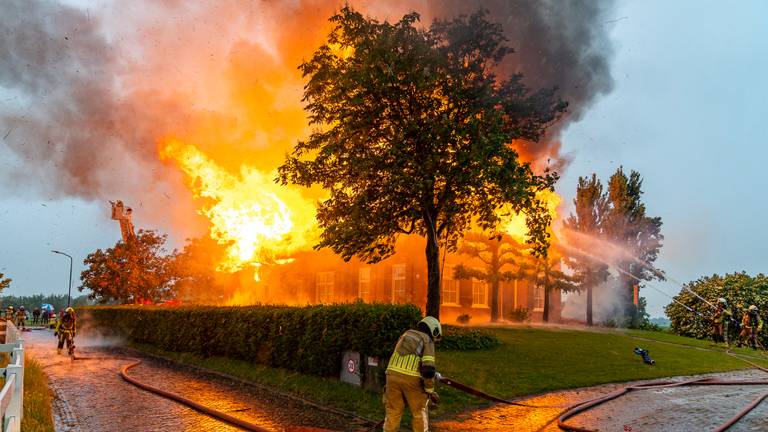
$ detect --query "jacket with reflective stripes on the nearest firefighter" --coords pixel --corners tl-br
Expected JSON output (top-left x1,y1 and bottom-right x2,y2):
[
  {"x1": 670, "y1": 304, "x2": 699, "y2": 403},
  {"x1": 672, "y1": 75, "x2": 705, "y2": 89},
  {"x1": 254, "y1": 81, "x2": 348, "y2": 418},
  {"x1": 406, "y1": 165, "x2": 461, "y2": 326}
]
[{"x1": 387, "y1": 330, "x2": 436, "y2": 393}]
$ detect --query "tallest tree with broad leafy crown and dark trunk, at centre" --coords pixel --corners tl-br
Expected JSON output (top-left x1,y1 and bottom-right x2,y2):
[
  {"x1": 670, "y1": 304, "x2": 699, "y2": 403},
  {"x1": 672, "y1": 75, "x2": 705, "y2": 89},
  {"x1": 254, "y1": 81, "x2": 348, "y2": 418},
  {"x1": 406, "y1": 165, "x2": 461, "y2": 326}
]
[{"x1": 278, "y1": 7, "x2": 566, "y2": 317}]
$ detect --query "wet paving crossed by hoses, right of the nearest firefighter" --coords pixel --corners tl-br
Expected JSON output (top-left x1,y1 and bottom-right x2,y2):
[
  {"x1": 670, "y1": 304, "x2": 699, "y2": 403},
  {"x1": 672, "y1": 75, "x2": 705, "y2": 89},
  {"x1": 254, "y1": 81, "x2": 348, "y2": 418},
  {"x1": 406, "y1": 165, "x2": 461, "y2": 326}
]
[{"x1": 433, "y1": 370, "x2": 768, "y2": 432}]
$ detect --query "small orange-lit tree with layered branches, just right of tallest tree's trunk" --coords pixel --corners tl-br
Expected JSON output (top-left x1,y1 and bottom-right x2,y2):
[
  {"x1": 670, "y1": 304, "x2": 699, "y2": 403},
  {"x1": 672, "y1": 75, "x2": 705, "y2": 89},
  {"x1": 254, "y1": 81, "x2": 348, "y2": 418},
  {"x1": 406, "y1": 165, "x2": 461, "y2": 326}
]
[{"x1": 454, "y1": 232, "x2": 524, "y2": 322}]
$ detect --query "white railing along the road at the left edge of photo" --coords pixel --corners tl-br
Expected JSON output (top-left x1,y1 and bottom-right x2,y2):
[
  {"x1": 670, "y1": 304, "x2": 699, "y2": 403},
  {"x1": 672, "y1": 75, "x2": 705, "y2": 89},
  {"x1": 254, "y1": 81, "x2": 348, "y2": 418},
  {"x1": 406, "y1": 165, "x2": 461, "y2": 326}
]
[{"x1": 0, "y1": 321, "x2": 24, "y2": 432}]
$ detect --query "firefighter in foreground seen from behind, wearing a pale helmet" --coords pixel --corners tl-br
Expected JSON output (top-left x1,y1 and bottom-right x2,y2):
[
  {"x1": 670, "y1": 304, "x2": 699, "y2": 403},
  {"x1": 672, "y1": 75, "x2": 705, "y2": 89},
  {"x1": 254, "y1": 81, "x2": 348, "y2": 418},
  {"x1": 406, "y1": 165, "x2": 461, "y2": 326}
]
[{"x1": 384, "y1": 316, "x2": 443, "y2": 432}]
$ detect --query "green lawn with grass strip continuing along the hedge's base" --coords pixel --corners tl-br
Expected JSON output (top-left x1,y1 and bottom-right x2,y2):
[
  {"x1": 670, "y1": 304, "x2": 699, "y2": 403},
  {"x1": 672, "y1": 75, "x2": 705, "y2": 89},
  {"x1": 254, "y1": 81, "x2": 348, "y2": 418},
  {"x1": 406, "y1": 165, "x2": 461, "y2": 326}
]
[{"x1": 129, "y1": 326, "x2": 768, "y2": 419}]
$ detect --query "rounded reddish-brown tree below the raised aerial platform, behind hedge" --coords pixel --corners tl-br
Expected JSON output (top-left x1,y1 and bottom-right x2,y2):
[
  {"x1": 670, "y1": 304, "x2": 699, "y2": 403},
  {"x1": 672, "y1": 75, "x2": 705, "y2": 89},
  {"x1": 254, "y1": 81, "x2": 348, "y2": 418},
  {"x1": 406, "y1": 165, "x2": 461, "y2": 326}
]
[{"x1": 78, "y1": 230, "x2": 175, "y2": 303}]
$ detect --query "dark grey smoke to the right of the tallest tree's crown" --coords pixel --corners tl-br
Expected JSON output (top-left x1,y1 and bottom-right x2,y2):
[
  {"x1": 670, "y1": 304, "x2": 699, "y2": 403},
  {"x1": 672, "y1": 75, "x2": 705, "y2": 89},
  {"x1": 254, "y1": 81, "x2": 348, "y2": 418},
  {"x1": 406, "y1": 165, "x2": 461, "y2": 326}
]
[{"x1": 428, "y1": 0, "x2": 614, "y2": 168}]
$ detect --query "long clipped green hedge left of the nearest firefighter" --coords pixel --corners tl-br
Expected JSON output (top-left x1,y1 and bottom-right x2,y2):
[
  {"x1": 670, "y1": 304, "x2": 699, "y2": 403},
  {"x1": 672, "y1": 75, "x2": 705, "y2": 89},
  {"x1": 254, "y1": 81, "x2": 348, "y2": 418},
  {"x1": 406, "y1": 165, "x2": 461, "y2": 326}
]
[{"x1": 79, "y1": 303, "x2": 421, "y2": 376}]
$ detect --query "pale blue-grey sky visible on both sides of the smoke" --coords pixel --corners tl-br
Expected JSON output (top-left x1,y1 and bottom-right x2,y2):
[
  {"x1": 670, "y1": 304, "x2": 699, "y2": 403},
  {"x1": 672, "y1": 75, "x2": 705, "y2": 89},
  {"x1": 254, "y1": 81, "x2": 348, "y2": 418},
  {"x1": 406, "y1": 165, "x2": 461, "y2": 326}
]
[{"x1": 0, "y1": 1, "x2": 768, "y2": 316}]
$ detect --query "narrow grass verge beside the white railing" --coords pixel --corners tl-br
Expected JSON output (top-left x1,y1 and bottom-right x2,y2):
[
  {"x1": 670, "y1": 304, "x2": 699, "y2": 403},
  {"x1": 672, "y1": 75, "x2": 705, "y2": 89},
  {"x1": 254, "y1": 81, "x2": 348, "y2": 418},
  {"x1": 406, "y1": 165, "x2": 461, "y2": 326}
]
[{"x1": 21, "y1": 358, "x2": 54, "y2": 432}]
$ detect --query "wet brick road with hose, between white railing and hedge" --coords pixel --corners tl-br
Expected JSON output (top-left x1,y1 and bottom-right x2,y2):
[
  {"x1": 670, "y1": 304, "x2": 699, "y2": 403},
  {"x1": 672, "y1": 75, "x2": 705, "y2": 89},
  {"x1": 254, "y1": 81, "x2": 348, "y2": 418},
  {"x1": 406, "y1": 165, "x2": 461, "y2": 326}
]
[{"x1": 24, "y1": 330, "x2": 361, "y2": 432}]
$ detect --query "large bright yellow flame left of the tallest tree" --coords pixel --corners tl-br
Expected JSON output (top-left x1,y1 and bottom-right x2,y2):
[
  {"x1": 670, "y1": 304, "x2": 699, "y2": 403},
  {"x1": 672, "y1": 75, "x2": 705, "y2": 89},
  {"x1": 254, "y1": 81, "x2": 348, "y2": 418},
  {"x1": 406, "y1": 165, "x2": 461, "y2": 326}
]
[{"x1": 160, "y1": 139, "x2": 317, "y2": 280}]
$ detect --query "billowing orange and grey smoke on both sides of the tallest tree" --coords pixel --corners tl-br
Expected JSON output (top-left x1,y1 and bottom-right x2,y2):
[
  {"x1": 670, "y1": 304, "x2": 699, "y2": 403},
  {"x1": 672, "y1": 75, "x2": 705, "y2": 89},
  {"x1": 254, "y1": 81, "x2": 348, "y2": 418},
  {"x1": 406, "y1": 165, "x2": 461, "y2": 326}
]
[{"x1": 0, "y1": 0, "x2": 612, "y2": 235}]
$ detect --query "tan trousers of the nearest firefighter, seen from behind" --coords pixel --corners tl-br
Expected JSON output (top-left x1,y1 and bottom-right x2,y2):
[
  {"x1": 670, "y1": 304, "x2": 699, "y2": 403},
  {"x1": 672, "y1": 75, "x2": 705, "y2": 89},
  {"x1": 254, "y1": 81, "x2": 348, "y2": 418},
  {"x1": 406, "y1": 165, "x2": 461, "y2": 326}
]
[{"x1": 384, "y1": 372, "x2": 429, "y2": 432}]
